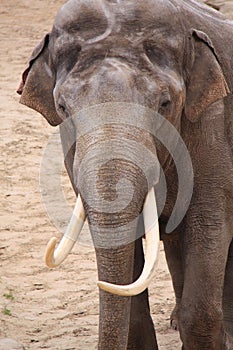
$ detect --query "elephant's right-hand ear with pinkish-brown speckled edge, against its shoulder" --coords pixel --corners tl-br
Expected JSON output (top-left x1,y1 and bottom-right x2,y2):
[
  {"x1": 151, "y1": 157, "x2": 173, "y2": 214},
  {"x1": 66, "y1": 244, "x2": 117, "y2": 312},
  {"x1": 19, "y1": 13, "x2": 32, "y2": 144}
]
[{"x1": 184, "y1": 29, "x2": 230, "y2": 122}]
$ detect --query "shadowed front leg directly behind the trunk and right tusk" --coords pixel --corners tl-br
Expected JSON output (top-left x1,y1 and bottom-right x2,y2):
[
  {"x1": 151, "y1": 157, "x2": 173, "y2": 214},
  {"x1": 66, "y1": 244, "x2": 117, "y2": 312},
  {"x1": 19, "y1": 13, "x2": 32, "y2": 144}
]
[{"x1": 127, "y1": 238, "x2": 158, "y2": 350}]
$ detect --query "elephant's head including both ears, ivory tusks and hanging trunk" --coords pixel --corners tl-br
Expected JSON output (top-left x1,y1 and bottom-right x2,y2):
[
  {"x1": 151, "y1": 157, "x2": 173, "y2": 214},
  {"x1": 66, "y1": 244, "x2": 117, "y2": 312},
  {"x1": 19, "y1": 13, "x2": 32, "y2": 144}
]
[{"x1": 19, "y1": 0, "x2": 228, "y2": 350}]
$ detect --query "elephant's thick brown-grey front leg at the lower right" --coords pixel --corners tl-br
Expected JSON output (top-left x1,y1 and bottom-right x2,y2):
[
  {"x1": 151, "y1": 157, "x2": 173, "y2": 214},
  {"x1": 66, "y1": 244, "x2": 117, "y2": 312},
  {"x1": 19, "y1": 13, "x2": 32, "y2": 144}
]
[{"x1": 179, "y1": 223, "x2": 232, "y2": 350}]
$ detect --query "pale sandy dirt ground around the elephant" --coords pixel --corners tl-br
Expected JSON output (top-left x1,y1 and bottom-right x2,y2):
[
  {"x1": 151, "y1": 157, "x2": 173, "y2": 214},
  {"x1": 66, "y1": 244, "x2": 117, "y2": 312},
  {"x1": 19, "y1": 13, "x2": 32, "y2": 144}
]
[{"x1": 0, "y1": 0, "x2": 232, "y2": 350}]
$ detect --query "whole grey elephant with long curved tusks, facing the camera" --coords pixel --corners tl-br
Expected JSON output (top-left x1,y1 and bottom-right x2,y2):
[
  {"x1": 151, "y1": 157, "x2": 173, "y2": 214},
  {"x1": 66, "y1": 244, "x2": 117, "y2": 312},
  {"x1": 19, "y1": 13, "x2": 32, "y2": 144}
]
[{"x1": 18, "y1": 0, "x2": 233, "y2": 350}]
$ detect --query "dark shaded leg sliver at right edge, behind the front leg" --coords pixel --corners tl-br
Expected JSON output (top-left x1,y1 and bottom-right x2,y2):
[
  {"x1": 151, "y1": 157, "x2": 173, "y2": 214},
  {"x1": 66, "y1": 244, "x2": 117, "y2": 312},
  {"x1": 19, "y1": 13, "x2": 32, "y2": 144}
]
[{"x1": 223, "y1": 241, "x2": 233, "y2": 345}]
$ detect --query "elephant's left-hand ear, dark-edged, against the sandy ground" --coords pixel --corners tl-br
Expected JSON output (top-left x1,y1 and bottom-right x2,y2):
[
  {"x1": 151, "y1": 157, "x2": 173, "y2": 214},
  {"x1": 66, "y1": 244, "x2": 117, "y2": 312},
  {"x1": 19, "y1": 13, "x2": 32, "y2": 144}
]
[{"x1": 17, "y1": 34, "x2": 62, "y2": 126}]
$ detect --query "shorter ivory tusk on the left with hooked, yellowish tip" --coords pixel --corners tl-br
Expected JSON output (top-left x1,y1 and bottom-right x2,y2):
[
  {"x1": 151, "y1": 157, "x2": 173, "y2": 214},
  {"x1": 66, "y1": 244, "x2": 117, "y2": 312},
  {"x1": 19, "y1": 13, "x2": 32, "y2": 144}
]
[{"x1": 45, "y1": 196, "x2": 86, "y2": 267}]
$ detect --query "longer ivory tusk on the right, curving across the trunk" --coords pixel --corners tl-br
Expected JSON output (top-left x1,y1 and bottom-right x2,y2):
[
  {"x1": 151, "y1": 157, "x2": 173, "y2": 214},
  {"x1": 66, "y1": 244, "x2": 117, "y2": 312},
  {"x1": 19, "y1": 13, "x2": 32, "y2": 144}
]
[{"x1": 97, "y1": 188, "x2": 160, "y2": 296}]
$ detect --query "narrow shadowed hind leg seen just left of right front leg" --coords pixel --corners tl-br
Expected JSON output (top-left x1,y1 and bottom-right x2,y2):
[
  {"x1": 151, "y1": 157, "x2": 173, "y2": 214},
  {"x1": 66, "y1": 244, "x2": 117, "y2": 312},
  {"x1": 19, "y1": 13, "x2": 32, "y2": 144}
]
[{"x1": 162, "y1": 228, "x2": 184, "y2": 330}]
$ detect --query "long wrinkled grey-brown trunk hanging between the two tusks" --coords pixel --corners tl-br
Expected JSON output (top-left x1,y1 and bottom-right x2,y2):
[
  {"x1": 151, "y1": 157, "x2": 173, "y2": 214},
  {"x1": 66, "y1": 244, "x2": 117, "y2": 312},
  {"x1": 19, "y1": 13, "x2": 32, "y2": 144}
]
[{"x1": 78, "y1": 150, "x2": 147, "y2": 350}]
